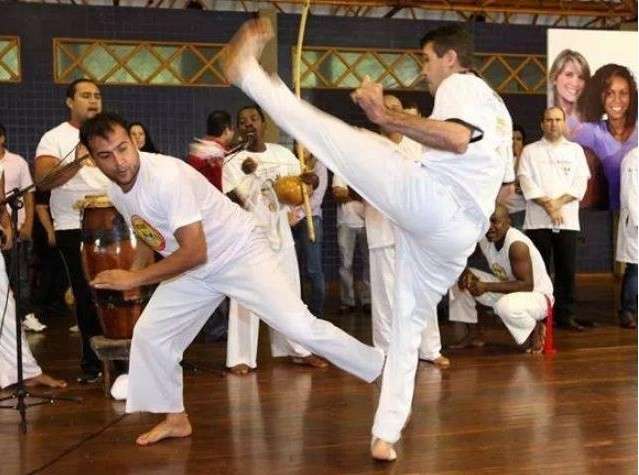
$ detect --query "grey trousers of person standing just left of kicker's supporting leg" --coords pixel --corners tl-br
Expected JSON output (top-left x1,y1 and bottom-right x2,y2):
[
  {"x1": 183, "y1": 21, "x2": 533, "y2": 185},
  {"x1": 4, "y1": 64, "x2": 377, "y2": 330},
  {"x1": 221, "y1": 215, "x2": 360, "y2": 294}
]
[{"x1": 337, "y1": 224, "x2": 371, "y2": 307}]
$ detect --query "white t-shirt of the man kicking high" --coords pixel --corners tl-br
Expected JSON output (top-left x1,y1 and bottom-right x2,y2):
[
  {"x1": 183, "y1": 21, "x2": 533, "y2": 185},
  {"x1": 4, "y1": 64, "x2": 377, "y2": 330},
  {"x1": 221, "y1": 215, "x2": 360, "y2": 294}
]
[{"x1": 421, "y1": 73, "x2": 512, "y2": 229}]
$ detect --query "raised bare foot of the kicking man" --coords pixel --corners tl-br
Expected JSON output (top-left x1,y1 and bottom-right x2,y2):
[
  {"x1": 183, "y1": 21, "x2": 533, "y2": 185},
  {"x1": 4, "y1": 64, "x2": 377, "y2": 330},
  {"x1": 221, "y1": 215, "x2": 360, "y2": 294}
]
[{"x1": 222, "y1": 18, "x2": 274, "y2": 86}]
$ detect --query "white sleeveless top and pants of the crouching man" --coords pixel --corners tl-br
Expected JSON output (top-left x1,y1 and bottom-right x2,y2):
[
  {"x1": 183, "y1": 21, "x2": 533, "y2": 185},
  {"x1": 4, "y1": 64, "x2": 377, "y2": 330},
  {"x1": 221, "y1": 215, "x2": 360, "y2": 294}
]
[{"x1": 449, "y1": 227, "x2": 554, "y2": 345}]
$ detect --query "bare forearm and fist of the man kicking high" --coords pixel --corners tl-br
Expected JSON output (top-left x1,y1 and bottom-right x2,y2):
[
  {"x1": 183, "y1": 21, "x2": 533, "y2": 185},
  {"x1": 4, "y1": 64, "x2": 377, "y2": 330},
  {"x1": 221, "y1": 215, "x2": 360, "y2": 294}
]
[{"x1": 352, "y1": 78, "x2": 472, "y2": 153}]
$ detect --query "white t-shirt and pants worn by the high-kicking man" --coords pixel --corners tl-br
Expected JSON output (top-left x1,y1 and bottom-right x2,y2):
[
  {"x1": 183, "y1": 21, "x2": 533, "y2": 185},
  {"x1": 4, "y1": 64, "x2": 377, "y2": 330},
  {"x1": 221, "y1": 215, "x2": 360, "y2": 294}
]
[{"x1": 240, "y1": 60, "x2": 512, "y2": 443}]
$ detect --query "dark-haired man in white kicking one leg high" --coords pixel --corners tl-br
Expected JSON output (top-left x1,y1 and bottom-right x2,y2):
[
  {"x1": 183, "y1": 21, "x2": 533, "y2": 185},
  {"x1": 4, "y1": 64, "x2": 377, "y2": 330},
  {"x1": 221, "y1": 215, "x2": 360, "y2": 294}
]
[{"x1": 225, "y1": 19, "x2": 512, "y2": 460}]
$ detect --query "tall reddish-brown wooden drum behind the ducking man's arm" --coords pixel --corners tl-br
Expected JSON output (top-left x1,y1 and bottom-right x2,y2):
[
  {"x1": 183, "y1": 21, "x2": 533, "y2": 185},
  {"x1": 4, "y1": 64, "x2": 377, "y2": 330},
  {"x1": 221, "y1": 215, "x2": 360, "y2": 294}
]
[{"x1": 77, "y1": 195, "x2": 151, "y2": 339}]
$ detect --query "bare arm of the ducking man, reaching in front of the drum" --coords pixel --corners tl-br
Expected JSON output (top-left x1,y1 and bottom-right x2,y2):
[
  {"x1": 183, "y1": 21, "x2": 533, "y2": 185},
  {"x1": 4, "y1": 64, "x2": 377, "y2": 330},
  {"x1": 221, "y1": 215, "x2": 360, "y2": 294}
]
[{"x1": 91, "y1": 221, "x2": 207, "y2": 290}]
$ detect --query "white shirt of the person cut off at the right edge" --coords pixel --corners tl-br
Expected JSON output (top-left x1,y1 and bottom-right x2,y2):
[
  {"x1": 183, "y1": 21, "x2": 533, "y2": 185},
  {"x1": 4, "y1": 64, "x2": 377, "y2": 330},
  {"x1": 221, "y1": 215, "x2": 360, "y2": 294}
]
[{"x1": 616, "y1": 148, "x2": 639, "y2": 264}]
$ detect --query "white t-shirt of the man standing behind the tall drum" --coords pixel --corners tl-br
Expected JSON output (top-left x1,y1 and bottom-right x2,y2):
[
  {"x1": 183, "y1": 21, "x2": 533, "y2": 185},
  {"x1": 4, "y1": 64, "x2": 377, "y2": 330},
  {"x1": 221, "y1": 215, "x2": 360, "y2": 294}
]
[{"x1": 36, "y1": 122, "x2": 109, "y2": 231}]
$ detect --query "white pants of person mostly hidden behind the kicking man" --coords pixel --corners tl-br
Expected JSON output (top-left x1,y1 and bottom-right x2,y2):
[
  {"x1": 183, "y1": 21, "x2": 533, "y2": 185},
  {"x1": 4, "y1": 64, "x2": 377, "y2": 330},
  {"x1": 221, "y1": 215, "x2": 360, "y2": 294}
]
[{"x1": 369, "y1": 246, "x2": 442, "y2": 361}]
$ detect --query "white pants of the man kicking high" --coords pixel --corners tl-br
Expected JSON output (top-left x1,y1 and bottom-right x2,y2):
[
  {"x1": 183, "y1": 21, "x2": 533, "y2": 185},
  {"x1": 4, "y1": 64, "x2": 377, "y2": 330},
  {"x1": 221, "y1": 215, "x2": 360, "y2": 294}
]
[{"x1": 241, "y1": 61, "x2": 486, "y2": 443}]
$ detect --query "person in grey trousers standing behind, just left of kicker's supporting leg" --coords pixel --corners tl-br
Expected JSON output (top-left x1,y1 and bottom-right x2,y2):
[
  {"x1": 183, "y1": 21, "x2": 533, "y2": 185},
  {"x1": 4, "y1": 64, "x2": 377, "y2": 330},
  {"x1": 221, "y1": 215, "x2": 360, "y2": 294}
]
[{"x1": 332, "y1": 173, "x2": 370, "y2": 313}]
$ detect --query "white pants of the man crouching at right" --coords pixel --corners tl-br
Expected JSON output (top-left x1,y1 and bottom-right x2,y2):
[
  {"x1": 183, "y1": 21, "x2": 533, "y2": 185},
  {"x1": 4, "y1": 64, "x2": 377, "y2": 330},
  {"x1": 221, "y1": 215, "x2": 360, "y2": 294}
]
[{"x1": 449, "y1": 269, "x2": 548, "y2": 345}]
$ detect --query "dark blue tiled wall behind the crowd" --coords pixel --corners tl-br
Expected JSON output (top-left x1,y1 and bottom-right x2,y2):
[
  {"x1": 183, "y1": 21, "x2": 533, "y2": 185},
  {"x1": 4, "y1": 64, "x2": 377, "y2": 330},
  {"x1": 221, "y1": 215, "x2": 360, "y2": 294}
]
[{"x1": 0, "y1": 3, "x2": 612, "y2": 279}]
